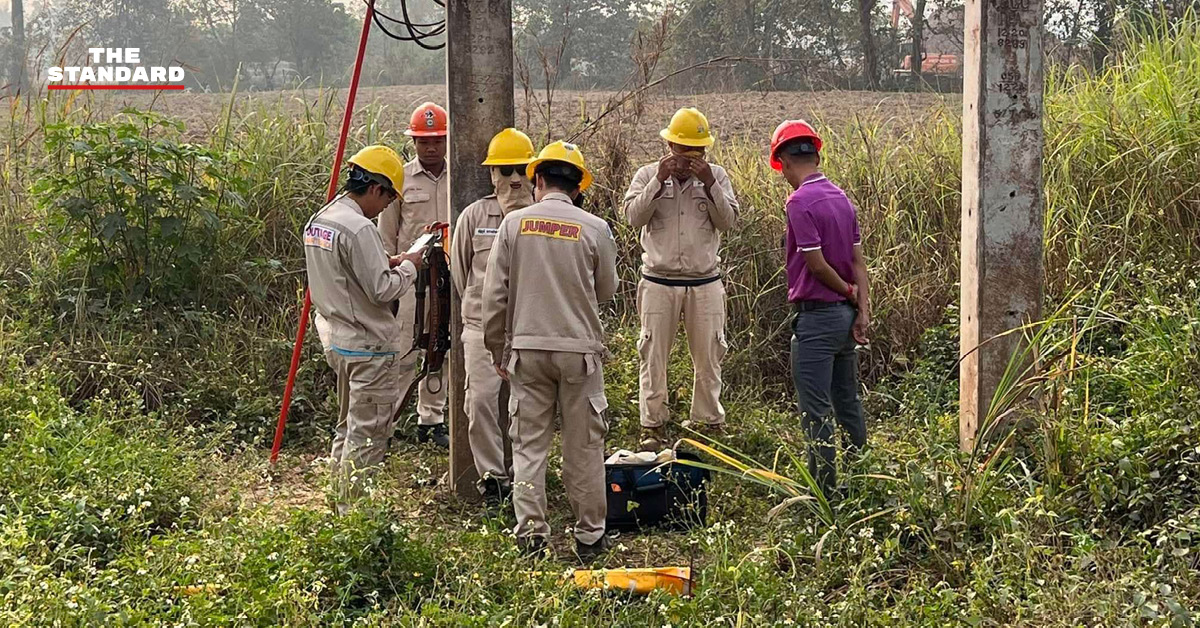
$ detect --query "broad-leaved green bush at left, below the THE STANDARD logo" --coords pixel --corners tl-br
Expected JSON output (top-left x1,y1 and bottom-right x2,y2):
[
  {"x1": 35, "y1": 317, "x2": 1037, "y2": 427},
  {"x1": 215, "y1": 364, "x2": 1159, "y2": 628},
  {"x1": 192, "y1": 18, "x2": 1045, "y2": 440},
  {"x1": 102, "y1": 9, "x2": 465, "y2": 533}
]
[{"x1": 34, "y1": 110, "x2": 242, "y2": 300}]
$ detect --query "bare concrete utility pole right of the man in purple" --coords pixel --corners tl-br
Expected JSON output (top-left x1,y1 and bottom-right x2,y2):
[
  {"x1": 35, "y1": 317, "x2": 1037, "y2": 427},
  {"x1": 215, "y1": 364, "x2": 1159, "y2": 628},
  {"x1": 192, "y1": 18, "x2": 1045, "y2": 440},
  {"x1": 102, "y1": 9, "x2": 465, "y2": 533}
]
[{"x1": 959, "y1": 0, "x2": 1044, "y2": 450}]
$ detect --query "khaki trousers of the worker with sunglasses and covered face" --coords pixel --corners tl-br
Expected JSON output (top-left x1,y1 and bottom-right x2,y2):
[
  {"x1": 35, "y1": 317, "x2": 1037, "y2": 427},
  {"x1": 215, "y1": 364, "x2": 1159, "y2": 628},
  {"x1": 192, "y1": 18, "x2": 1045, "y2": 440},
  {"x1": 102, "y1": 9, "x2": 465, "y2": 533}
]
[{"x1": 462, "y1": 329, "x2": 512, "y2": 484}]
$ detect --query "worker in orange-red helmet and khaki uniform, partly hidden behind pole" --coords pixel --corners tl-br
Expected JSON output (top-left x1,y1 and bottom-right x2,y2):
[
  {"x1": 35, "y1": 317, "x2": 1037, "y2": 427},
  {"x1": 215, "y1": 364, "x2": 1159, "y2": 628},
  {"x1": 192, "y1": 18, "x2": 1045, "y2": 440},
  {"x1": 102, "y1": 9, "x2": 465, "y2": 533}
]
[{"x1": 379, "y1": 102, "x2": 450, "y2": 448}]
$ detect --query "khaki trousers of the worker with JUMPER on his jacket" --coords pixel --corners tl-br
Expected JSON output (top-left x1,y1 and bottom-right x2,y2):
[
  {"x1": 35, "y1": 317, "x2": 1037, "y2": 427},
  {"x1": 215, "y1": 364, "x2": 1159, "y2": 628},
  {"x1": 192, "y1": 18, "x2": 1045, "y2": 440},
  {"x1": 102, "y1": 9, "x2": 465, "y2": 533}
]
[{"x1": 508, "y1": 349, "x2": 608, "y2": 545}]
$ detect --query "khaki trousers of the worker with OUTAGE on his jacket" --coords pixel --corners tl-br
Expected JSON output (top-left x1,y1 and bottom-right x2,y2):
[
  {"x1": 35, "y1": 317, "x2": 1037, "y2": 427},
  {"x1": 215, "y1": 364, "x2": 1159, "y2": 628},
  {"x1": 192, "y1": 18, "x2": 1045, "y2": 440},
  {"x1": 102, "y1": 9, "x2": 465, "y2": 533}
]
[{"x1": 325, "y1": 351, "x2": 412, "y2": 512}]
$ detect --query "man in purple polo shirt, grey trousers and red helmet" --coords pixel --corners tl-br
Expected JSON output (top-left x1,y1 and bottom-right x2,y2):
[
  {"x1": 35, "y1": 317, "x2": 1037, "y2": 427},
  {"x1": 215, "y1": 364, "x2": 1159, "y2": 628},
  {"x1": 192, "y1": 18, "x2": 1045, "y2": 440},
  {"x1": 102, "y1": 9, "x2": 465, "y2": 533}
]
[{"x1": 770, "y1": 120, "x2": 870, "y2": 496}]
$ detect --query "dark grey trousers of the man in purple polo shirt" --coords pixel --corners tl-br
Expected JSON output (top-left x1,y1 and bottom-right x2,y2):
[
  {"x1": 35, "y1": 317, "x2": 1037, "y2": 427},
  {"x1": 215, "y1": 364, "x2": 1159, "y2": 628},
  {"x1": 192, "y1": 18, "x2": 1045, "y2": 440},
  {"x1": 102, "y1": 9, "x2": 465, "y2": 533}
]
[{"x1": 792, "y1": 304, "x2": 866, "y2": 495}]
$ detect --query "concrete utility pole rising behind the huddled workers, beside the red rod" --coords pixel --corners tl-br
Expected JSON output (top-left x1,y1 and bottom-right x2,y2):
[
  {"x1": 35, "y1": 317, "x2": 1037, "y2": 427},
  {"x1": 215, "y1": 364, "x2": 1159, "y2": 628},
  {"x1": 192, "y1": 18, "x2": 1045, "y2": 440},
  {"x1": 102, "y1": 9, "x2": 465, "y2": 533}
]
[{"x1": 445, "y1": 0, "x2": 516, "y2": 500}]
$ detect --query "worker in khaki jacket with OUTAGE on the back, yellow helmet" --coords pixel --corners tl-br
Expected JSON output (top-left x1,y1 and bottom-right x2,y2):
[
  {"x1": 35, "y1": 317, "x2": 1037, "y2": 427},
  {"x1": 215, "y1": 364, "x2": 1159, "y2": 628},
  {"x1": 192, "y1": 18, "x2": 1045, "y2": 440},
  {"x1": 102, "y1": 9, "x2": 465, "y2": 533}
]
[{"x1": 304, "y1": 145, "x2": 421, "y2": 512}]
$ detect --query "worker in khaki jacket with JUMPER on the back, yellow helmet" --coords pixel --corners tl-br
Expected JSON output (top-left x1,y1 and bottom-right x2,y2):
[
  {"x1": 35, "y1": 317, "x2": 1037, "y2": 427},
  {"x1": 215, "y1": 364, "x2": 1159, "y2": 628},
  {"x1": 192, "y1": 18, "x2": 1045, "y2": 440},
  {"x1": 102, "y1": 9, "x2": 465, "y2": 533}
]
[{"x1": 484, "y1": 142, "x2": 617, "y2": 562}]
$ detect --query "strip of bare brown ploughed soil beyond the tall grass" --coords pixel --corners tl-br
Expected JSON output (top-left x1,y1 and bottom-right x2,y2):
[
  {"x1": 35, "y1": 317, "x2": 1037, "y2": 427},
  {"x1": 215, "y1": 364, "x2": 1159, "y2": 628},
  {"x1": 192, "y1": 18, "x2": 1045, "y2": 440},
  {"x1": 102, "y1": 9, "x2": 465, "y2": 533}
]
[{"x1": 72, "y1": 85, "x2": 961, "y2": 157}]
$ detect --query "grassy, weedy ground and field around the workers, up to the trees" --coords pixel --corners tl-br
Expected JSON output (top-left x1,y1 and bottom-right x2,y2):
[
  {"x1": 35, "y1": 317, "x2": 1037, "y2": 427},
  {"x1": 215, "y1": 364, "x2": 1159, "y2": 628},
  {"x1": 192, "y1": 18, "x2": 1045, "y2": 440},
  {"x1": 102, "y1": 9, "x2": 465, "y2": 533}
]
[{"x1": 0, "y1": 20, "x2": 1200, "y2": 627}]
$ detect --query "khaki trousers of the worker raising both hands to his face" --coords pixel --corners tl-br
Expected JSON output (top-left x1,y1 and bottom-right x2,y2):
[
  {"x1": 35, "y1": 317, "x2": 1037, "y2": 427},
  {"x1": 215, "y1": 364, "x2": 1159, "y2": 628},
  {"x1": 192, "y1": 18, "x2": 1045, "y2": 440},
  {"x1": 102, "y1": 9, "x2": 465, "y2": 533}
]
[{"x1": 637, "y1": 279, "x2": 728, "y2": 427}]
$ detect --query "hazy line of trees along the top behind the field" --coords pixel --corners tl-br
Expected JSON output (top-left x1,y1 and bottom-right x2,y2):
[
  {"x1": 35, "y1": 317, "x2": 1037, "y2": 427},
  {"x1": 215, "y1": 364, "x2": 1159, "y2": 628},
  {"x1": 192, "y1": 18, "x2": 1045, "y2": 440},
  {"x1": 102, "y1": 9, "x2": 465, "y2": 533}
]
[{"x1": 0, "y1": 0, "x2": 1200, "y2": 91}]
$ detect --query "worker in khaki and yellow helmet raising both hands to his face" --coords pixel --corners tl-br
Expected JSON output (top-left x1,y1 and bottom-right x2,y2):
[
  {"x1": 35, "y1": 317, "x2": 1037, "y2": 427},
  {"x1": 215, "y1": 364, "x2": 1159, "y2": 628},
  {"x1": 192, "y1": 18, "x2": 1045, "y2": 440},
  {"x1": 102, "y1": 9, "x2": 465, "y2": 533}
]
[{"x1": 625, "y1": 108, "x2": 738, "y2": 450}]
